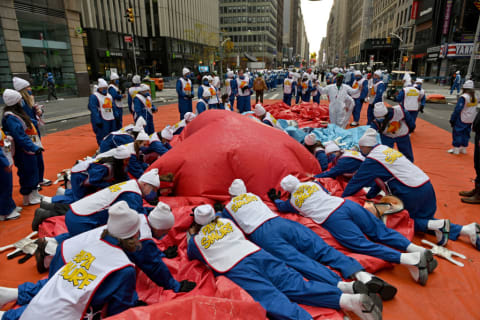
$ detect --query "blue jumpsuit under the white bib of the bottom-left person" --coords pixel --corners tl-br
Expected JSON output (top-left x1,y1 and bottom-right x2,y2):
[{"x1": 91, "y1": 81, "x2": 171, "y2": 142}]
[{"x1": 2, "y1": 235, "x2": 138, "y2": 320}]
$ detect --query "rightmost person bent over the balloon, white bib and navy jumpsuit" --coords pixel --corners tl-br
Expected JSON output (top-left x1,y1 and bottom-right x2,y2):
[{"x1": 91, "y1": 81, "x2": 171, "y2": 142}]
[{"x1": 342, "y1": 128, "x2": 480, "y2": 250}]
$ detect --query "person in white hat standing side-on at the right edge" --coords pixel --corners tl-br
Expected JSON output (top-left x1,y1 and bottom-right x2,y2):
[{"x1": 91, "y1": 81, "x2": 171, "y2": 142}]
[{"x1": 448, "y1": 80, "x2": 478, "y2": 154}]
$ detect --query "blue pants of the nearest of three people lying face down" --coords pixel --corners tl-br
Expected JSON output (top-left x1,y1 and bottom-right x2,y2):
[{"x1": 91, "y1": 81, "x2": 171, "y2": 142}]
[{"x1": 224, "y1": 250, "x2": 342, "y2": 320}]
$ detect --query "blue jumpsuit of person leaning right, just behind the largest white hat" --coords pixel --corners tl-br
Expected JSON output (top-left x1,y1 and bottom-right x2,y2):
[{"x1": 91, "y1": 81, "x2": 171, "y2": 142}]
[{"x1": 65, "y1": 192, "x2": 145, "y2": 237}]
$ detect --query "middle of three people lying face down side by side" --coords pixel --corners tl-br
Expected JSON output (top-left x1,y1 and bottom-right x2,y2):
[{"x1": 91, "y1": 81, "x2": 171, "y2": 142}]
[{"x1": 221, "y1": 179, "x2": 393, "y2": 299}]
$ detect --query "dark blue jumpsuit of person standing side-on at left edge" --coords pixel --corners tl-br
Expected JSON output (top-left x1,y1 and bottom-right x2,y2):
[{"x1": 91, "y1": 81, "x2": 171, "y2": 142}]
[{"x1": 2, "y1": 115, "x2": 40, "y2": 195}]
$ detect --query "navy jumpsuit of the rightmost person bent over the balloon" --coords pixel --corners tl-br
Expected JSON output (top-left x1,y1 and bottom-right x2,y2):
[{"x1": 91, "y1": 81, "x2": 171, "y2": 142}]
[{"x1": 342, "y1": 154, "x2": 462, "y2": 240}]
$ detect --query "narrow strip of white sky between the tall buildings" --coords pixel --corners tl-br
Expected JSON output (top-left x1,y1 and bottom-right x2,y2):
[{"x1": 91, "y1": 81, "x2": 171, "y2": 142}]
[{"x1": 301, "y1": 0, "x2": 333, "y2": 54}]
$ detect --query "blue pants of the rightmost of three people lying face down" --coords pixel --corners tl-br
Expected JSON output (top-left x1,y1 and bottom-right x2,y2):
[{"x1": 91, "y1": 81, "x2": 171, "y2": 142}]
[{"x1": 322, "y1": 200, "x2": 410, "y2": 263}]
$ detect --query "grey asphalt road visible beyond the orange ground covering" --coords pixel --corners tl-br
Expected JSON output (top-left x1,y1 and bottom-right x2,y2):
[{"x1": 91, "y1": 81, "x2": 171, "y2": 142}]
[{"x1": 37, "y1": 88, "x2": 455, "y2": 138}]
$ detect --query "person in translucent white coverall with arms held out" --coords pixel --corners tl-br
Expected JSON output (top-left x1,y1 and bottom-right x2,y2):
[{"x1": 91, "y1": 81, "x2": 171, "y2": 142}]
[{"x1": 320, "y1": 73, "x2": 358, "y2": 128}]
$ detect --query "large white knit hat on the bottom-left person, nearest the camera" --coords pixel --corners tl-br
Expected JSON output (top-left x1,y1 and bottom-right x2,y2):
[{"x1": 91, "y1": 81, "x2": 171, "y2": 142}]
[{"x1": 107, "y1": 201, "x2": 140, "y2": 239}]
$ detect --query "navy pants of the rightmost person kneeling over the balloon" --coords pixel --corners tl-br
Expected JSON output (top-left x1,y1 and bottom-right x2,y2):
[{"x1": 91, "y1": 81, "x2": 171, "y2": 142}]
[{"x1": 393, "y1": 181, "x2": 462, "y2": 241}]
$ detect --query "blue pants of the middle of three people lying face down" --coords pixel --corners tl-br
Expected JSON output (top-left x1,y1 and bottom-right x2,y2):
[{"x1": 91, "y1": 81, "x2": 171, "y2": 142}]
[{"x1": 249, "y1": 217, "x2": 363, "y2": 286}]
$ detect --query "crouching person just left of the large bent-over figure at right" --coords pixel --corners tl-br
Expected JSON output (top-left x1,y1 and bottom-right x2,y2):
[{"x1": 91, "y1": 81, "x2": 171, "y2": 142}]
[{"x1": 315, "y1": 141, "x2": 365, "y2": 179}]
